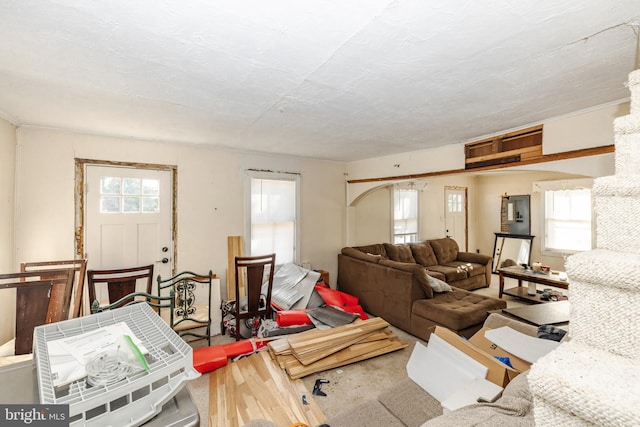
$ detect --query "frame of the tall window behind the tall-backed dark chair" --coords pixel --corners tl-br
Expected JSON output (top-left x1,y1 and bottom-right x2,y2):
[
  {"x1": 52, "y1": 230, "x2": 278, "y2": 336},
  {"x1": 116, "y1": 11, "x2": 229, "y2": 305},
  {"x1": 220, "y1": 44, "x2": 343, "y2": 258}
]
[{"x1": 244, "y1": 169, "x2": 301, "y2": 266}]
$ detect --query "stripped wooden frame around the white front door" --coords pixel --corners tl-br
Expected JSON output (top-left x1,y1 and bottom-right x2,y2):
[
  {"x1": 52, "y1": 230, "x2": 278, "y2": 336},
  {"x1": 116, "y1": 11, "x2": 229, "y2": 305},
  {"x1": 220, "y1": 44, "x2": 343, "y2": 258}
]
[{"x1": 74, "y1": 158, "x2": 178, "y2": 274}]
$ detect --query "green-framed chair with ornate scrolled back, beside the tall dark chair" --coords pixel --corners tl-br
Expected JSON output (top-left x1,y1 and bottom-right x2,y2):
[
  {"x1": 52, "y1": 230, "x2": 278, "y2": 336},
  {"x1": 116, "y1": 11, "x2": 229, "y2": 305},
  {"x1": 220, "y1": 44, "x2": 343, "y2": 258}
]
[{"x1": 157, "y1": 271, "x2": 214, "y2": 345}]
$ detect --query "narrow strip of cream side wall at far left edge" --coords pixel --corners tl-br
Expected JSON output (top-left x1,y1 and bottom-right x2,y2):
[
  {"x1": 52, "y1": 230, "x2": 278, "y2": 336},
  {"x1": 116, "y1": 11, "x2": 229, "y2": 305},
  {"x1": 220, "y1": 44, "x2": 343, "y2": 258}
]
[{"x1": 0, "y1": 118, "x2": 18, "y2": 345}]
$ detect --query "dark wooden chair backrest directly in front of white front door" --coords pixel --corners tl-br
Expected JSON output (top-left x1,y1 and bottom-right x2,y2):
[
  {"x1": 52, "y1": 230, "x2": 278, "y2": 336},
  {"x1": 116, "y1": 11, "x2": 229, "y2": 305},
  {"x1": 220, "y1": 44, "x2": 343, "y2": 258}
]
[{"x1": 87, "y1": 264, "x2": 153, "y2": 304}]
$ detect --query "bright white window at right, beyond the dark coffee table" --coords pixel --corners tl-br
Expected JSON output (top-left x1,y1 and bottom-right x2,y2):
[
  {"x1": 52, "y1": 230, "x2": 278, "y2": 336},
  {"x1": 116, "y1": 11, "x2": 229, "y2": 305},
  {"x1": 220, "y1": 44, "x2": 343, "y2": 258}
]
[{"x1": 534, "y1": 180, "x2": 593, "y2": 255}]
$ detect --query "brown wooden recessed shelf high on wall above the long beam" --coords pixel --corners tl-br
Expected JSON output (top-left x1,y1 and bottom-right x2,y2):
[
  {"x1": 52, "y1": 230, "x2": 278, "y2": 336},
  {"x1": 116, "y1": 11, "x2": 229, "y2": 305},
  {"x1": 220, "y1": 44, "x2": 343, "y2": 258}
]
[{"x1": 464, "y1": 125, "x2": 542, "y2": 169}]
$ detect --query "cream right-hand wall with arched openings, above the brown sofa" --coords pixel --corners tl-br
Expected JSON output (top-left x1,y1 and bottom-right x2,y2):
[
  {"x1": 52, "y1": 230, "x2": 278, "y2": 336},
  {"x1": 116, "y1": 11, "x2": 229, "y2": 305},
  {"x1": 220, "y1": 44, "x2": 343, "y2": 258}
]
[{"x1": 347, "y1": 103, "x2": 629, "y2": 269}]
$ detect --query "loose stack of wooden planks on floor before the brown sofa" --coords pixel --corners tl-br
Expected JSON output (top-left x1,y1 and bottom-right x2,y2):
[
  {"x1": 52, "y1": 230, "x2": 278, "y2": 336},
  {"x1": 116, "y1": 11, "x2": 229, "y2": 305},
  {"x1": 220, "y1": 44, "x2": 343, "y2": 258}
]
[{"x1": 269, "y1": 317, "x2": 407, "y2": 379}]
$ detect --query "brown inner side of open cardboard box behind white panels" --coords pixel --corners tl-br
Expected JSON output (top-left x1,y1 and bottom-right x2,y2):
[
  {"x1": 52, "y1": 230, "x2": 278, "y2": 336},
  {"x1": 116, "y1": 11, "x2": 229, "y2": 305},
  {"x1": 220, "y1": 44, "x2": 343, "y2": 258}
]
[{"x1": 432, "y1": 326, "x2": 526, "y2": 387}]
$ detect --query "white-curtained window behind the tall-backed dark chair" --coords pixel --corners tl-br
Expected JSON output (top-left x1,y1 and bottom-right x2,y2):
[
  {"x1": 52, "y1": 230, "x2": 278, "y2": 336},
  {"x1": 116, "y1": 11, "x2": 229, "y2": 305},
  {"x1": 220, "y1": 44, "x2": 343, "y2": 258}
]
[{"x1": 248, "y1": 173, "x2": 300, "y2": 265}]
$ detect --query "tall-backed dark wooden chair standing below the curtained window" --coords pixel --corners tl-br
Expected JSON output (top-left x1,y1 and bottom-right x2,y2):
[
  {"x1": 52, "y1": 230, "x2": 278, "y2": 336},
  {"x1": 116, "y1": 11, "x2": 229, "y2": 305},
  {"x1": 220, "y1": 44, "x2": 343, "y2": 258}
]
[{"x1": 233, "y1": 254, "x2": 276, "y2": 341}]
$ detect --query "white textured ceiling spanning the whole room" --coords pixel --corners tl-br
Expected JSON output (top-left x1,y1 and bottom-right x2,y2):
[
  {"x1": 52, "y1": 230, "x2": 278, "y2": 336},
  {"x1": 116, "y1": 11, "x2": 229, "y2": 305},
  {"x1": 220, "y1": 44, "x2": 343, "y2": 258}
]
[{"x1": 0, "y1": 0, "x2": 640, "y2": 161}]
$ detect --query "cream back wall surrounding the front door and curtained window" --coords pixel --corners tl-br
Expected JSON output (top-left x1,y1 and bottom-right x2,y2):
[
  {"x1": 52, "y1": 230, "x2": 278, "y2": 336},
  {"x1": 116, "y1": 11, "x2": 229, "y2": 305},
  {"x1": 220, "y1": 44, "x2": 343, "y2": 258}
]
[{"x1": 14, "y1": 128, "x2": 346, "y2": 336}]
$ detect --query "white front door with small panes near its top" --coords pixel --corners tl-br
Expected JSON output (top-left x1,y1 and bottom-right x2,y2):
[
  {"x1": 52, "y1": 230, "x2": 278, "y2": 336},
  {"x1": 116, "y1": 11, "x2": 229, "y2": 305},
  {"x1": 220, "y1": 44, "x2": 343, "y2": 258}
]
[{"x1": 85, "y1": 165, "x2": 173, "y2": 301}]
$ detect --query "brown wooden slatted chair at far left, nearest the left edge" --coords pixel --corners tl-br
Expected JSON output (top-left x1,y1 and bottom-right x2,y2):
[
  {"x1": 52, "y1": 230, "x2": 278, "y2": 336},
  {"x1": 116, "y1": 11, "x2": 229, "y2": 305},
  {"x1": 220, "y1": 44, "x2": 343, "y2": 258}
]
[{"x1": 0, "y1": 268, "x2": 75, "y2": 355}]
